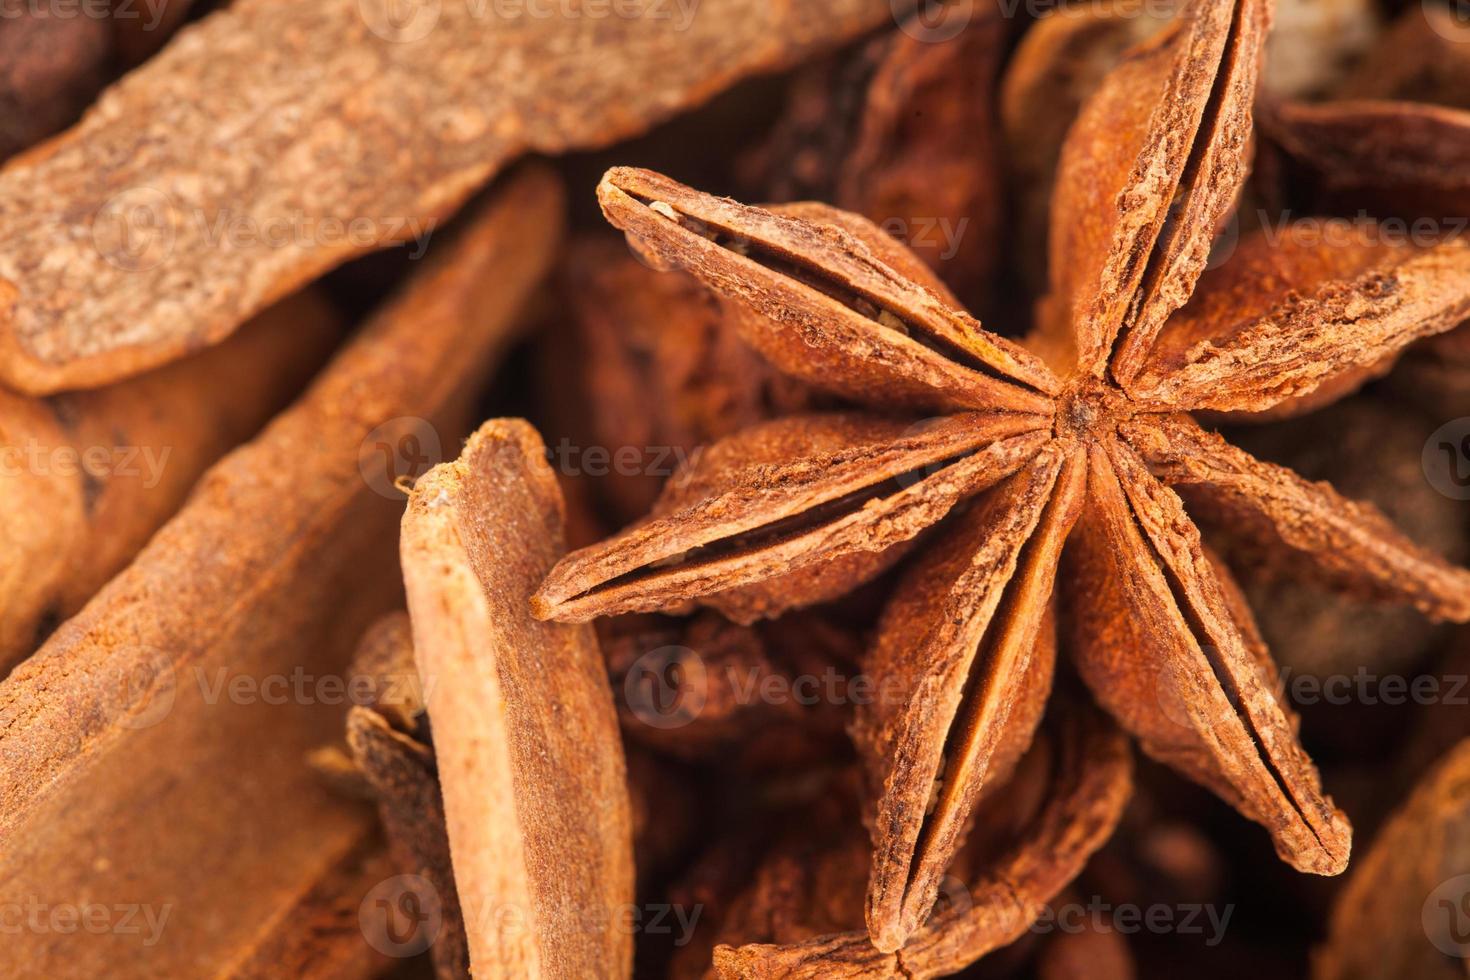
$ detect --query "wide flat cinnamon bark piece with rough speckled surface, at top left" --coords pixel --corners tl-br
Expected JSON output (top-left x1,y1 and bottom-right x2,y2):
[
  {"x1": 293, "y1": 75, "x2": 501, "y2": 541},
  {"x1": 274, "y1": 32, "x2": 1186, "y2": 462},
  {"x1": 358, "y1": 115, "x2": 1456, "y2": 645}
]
[{"x1": 0, "y1": 0, "x2": 888, "y2": 392}]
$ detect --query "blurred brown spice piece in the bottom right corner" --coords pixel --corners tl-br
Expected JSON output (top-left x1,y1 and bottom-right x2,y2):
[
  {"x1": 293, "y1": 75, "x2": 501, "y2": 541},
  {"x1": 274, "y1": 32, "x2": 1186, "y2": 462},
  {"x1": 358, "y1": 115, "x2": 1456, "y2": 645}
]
[{"x1": 1311, "y1": 742, "x2": 1470, "y2": 980}]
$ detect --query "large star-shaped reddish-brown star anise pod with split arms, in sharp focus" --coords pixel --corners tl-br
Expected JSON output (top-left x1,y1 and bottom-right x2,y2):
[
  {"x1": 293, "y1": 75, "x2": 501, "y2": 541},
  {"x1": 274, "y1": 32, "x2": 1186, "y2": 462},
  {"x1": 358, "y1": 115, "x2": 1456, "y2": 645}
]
[{"x1": 534, "y1": 0, "x2": 1470, "y2": 952}]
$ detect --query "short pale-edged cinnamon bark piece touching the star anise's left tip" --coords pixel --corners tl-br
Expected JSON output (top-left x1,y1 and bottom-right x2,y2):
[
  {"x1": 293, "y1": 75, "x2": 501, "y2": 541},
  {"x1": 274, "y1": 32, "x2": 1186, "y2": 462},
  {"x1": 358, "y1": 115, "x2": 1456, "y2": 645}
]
[{"x1": 401, "y1": 422, "x2": 634, "y2": 977}]
